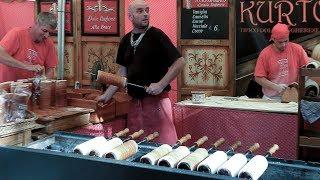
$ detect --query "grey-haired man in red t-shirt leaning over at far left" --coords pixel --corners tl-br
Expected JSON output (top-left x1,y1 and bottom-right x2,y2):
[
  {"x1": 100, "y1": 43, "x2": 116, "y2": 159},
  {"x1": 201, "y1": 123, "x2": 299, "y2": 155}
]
[{"x1": 0, "y1": 12, "x2": 58, "y2": 82}]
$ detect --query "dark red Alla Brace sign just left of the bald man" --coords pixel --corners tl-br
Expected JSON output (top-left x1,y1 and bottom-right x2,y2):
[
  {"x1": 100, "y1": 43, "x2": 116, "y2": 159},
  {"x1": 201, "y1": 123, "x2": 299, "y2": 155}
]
[{"x1": 82, "y1": 0, "x2": 119, "y2": 35}]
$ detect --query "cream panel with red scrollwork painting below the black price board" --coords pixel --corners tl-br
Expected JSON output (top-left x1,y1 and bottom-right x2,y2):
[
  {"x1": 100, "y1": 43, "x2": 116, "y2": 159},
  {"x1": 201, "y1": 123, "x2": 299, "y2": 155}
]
[{"x1": 182, "y1": 46, "x2": 229, "y2": 87}]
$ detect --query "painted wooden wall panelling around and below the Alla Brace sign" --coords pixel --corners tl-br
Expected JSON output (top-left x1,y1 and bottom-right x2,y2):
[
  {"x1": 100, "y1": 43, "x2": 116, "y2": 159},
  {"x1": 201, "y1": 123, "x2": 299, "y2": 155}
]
[{"x1": 35, "y1": 0, "x2": 125, "y2": 86}]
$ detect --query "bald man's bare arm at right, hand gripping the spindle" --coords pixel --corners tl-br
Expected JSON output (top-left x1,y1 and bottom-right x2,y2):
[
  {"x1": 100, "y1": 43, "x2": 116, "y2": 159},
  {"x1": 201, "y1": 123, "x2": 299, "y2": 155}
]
[{"x1": 146, "y1": 57, "x2": 186, "y2": 95}]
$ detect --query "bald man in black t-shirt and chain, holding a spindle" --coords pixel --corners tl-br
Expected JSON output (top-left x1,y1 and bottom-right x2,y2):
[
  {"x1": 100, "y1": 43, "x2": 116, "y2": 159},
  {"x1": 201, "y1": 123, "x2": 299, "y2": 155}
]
[{"x1": 97, "y1": 0, "x2": 185, "y2": 144}]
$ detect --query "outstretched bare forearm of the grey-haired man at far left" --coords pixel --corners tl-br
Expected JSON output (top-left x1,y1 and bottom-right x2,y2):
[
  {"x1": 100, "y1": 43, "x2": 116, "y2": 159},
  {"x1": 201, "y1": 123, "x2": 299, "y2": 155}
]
[{"x1": 0, "y1": 46, "x2": 43, "y2": 72}]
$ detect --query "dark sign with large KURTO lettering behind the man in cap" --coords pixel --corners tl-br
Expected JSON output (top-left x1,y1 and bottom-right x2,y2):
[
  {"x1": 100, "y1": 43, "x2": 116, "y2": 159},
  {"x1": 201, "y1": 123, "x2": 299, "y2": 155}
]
[{"x1": 236, "y1": 0, "x2": 320, "y2": 63}]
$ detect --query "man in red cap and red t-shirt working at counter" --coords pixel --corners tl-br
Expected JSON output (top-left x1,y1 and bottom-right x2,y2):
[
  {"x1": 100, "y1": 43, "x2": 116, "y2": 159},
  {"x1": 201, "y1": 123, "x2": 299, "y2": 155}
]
[{"x1": 254, "y1": 23, "x2": 309, "y2": 100}]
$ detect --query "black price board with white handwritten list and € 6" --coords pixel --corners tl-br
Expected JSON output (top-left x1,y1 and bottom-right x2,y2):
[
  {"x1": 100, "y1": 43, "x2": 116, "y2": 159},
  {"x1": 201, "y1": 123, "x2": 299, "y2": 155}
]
[{"x1": 181, "y1": 0, "x2": 229, "y2": 39}]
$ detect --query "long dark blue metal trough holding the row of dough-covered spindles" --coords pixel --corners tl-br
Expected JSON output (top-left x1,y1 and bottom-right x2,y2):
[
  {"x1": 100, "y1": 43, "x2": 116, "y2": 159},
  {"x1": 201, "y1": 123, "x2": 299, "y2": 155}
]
[{"x1": 21, "y1": 130, "x2": 320, "y2": 180}]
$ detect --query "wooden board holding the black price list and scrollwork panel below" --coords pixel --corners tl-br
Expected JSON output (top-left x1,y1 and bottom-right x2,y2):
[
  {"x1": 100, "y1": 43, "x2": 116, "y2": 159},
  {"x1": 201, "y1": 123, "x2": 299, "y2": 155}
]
[{"x1": 177, "y1": 0, "x2": 235, "y2": 101}]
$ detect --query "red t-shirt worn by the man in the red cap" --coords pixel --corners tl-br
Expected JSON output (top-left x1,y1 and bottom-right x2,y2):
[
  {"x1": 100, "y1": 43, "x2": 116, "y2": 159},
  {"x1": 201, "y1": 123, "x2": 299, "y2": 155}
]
[{"x1": 254, "y1": 42, "x2": 309, "y2": 97}]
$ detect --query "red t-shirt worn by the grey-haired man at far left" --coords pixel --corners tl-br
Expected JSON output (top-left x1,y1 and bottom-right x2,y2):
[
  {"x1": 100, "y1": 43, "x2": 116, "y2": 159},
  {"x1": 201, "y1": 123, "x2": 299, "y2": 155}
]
[{"x1": 0, "y1": 28, "x2": 58, "y2": 82}]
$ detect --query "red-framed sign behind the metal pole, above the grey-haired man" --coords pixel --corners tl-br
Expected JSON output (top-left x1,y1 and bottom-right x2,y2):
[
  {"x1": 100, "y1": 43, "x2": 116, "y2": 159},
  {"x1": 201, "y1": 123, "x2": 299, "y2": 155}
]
[{"x1": 38, "y1": 0, "x2": 72, "y2": 35}]
